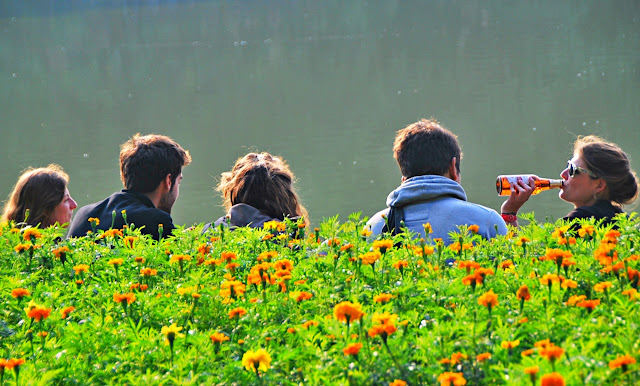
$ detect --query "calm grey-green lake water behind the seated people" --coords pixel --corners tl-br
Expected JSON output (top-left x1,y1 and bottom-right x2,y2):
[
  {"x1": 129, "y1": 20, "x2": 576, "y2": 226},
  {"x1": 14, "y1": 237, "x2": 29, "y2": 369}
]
[{"x1": 0, "y1": 0, "x2": 640, "y2": 228}]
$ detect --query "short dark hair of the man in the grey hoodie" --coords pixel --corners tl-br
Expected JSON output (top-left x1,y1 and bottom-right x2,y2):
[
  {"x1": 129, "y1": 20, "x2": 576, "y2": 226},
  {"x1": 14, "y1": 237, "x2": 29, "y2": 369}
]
[{"x1": 393, "y1": 118, "x2": 462, "y2": 178}]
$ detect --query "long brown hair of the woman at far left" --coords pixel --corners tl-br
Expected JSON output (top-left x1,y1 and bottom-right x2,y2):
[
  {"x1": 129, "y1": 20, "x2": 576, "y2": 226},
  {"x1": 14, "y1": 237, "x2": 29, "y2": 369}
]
[{"x1": 2, "y1": 164, "x2": 69, "y2": 227}]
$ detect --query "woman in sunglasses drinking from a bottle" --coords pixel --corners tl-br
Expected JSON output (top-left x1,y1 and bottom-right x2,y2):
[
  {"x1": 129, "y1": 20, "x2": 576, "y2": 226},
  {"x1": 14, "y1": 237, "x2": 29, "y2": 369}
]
[{"x1": 501, "y1": 135, "x2": 638, "y2": 226}]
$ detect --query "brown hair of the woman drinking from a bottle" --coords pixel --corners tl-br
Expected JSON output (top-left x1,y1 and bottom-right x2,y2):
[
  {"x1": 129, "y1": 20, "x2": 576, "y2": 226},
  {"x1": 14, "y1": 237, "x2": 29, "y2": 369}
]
[{"x1": 573, "y1": 135, "x2": 638, "y2": 205}]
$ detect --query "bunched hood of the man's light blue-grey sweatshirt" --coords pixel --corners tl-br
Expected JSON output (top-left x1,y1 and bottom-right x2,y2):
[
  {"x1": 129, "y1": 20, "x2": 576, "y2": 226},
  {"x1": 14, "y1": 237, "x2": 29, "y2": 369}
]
[{"x1": 387, "y1": 175, "x2": 467, "y2": 207}]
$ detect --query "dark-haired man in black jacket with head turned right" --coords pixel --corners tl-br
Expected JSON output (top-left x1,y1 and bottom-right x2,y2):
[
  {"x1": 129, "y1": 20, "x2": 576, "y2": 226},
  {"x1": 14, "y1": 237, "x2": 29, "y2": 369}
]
[{"x1": 69, "y1": 134, "x2": 191, "y2": 240}]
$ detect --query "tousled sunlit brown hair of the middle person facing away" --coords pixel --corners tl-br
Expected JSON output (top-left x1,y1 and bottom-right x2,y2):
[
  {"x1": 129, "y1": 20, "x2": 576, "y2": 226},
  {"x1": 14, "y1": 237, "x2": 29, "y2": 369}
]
[{"x1": 217, "y1": 152, "x2": 309, "y2": 226}]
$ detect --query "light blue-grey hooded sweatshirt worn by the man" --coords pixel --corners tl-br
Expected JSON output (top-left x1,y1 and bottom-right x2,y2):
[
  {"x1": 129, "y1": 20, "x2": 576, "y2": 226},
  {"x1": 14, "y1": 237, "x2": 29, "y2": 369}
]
[{"x1": 367, "y1": 175, "x2": 507, "y2": 244}]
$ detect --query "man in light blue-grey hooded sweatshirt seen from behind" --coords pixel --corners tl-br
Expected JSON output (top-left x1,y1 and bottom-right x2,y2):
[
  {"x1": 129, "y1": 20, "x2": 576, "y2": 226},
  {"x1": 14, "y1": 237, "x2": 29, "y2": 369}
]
[{"x1": 367, "y1": 119, "x2": 507, "y2": 244}]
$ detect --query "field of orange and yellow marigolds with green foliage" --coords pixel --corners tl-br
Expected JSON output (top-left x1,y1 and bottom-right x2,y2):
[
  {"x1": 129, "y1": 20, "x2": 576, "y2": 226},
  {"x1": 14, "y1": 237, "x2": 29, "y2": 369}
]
[{"x1": 0, "y1": 214, "x2": 640, "y2": 385}]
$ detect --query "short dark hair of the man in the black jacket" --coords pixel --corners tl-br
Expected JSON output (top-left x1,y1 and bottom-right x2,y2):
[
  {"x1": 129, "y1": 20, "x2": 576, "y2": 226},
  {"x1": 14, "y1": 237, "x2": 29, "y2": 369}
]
[{"x1": 120, "y1": 133, "x2": 191, "y2": 193}]
